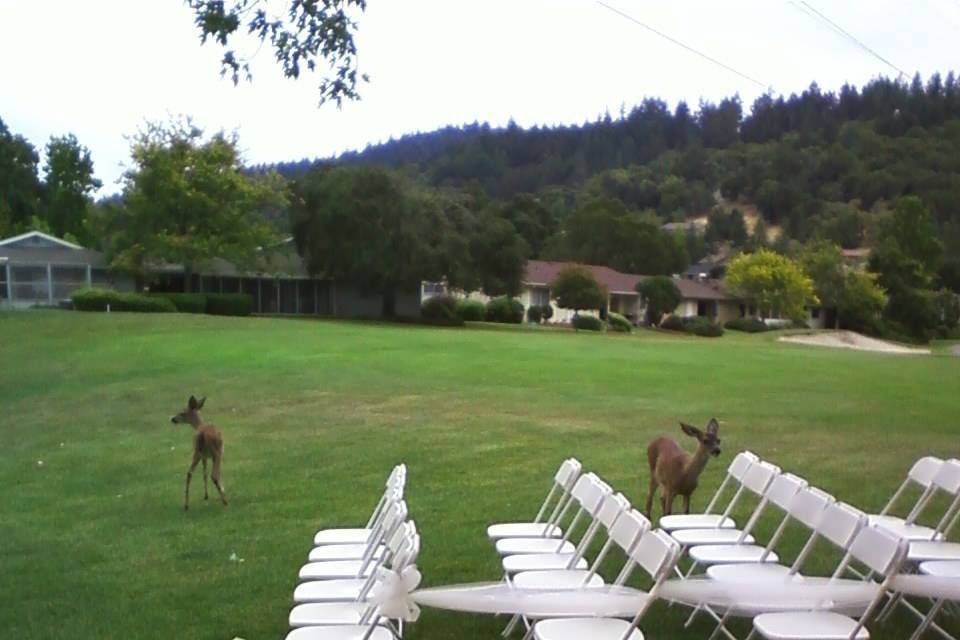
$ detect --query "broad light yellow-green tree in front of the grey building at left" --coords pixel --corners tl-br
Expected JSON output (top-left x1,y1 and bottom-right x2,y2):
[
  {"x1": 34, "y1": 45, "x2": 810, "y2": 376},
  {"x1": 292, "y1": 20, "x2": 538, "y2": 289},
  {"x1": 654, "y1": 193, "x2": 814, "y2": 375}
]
[{"x1": 113, "y1": 122, "x2": 285, "y2": 291}]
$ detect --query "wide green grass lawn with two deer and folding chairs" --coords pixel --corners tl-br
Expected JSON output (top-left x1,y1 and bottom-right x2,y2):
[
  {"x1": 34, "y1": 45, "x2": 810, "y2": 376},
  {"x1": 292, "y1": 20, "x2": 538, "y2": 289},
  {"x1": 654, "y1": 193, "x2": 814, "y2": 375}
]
[{"x1": 0, "y1": 312, "x2": 960, "y2": 640}]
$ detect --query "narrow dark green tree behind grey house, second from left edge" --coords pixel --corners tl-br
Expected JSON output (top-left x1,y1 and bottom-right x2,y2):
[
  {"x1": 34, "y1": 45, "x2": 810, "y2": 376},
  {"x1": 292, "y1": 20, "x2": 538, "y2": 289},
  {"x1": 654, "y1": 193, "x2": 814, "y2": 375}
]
[{"x1": 44, "y1": 134, "x2": 102, "y2": 244}]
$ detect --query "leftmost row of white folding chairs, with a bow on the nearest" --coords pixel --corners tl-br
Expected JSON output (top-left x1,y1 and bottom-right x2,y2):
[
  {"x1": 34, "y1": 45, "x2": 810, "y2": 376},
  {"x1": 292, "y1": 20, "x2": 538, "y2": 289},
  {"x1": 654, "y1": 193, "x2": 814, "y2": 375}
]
[{"x1": 287, "y1": 464, "x2": 420, "y2": 640}]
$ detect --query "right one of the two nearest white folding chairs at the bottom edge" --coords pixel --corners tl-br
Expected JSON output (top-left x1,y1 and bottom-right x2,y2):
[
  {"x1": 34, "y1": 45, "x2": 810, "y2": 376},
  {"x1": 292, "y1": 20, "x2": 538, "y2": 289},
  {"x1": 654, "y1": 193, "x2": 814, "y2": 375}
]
[{"x1": 750, "y1": 527, "x2": 908, "y2": 640}]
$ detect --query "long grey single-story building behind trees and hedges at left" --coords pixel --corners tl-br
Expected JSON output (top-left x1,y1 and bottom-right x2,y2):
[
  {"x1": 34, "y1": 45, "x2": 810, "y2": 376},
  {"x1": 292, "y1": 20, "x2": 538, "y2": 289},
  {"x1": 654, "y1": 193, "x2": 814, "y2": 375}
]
[{"x1": 0, "y1": 231, "x2": 420, "y2": 318}]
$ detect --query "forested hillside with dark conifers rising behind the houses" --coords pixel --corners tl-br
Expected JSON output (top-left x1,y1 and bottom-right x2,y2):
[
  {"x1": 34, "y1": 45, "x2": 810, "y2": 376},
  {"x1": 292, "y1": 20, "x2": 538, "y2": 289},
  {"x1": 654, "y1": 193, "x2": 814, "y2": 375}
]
[{"x1": 258, "y1": 72, "x2": 960, "y2": 262}]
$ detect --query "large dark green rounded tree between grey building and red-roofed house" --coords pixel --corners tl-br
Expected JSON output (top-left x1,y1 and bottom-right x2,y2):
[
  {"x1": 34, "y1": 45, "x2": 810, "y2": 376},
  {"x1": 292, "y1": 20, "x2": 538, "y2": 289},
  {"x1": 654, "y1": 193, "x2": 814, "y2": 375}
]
[{"x1": 291, "y1": 167, "x2": 456, "y2": 318}]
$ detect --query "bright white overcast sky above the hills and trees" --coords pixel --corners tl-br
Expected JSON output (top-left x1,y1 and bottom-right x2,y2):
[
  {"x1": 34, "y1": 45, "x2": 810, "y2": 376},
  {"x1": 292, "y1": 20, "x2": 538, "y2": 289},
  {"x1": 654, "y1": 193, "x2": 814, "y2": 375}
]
[{"x1": 0, "y1": 0, "x2": 960, "y2": 193}]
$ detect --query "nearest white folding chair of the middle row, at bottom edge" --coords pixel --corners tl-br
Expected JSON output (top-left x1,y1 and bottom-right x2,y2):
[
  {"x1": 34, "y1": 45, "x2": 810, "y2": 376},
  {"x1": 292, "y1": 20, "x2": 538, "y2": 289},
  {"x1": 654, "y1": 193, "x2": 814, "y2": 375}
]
[{"x1": 533, "y1": 530, "x2": 680, "y2": 640}]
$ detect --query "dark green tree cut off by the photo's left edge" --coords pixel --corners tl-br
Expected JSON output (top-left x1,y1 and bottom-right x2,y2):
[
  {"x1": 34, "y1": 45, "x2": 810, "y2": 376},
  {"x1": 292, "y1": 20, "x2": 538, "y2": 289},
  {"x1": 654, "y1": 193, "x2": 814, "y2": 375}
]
[{"x1": 0, "y1": 119, "x2": 42, "y2": 237}]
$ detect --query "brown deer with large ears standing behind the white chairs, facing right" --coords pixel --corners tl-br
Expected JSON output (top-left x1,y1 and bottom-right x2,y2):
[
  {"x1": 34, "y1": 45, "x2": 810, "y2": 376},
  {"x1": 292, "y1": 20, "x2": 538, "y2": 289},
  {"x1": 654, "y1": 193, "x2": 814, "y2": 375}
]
[{"x1": 647, "y1": 418, "x2": 720, "y2": 518}]
